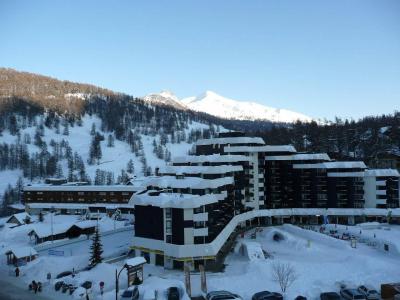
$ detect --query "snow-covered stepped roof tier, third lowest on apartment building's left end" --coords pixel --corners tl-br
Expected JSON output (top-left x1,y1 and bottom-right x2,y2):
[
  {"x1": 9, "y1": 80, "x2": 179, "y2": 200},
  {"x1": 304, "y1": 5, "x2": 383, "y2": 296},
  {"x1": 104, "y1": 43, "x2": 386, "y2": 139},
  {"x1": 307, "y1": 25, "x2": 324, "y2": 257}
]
[{"x1": 159, "y1": 165, "x2": 243, "y2": 175}]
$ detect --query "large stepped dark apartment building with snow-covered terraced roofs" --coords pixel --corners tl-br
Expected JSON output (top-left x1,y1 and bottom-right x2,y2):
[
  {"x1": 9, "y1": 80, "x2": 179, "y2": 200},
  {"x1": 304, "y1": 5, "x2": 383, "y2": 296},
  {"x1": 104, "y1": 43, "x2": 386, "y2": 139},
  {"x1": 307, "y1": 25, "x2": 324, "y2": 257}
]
[{"x1": 133, "y1": 132, "x2": 399, "y2": 268}]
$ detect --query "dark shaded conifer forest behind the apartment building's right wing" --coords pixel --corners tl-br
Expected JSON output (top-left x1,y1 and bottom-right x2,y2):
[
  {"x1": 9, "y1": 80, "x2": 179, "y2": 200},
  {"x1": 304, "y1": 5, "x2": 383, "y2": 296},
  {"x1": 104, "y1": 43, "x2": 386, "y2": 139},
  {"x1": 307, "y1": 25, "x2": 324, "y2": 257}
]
[{"x1": 254, "y1": 112, "x2": 400, "y2": 160}]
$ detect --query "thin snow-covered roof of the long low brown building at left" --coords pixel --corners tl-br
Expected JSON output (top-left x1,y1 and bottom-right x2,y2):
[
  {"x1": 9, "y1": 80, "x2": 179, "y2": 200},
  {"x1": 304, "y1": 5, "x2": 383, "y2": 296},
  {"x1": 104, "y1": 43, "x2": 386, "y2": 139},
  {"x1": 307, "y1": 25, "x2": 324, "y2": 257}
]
[{"x1": 24, "y1": 184, "x2": 138, "y2": 192}]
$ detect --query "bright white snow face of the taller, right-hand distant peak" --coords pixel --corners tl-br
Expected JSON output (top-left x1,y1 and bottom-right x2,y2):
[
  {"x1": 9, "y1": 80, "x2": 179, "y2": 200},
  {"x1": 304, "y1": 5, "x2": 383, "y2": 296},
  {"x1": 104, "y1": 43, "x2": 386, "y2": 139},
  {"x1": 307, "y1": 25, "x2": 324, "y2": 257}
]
[{"x1": 181, "y1": 91, "x2": 312, "y2": 123}]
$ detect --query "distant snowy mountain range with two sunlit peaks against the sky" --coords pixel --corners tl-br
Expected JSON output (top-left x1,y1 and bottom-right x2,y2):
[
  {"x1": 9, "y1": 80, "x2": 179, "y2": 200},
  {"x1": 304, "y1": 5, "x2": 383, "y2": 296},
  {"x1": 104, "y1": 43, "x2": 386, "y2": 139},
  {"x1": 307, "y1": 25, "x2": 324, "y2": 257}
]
[{"x1": 144, "y1": 91, "x2": 313, "y2": 123}]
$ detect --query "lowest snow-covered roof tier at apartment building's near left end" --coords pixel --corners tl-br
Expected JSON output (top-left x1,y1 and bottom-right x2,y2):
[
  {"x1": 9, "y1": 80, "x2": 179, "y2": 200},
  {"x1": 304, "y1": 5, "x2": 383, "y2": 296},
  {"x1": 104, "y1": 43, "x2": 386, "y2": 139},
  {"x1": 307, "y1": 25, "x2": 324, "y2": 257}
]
[{"x1": 132, "y1": 190, "x2": 227, "y2": 208}]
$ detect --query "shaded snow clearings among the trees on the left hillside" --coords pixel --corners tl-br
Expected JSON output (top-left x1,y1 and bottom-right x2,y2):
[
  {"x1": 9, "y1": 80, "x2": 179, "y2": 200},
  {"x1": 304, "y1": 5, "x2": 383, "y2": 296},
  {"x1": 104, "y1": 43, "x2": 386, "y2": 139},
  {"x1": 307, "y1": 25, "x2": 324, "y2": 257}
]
[{"x1": 0, "y1": 114, "x2": 214, "y2": 196}]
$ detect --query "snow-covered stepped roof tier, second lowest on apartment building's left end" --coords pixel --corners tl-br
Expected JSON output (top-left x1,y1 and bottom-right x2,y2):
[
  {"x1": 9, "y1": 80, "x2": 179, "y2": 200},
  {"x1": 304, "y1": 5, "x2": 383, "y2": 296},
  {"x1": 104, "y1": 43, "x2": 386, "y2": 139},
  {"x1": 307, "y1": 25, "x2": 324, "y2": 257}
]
[{"x1": 146, "y1": 176, "x2": 233, "y2": 189}]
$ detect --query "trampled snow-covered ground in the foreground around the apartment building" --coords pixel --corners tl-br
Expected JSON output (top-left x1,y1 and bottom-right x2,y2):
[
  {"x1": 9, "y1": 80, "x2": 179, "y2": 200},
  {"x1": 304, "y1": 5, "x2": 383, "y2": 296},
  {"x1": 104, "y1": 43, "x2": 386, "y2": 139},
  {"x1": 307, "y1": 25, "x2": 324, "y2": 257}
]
[{"x1": 1, "y1": 224, "x2": 400, "y2": 300}]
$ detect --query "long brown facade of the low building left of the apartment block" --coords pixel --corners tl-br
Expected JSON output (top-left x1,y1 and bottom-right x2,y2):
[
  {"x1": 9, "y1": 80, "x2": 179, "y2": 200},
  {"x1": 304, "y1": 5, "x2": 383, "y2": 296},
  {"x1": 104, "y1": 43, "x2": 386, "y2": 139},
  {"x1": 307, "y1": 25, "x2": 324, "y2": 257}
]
[{"x1": 23, "y1": 190, "x2": 134, "y2": 204}]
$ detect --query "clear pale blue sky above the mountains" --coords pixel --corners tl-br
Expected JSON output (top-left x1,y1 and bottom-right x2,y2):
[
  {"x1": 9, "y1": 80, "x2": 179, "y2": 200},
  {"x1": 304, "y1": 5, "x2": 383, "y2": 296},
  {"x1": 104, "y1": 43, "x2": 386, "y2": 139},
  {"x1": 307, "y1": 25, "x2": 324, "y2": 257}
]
[{"x1": 0, "y1": 0, "x2": 400, "y2": 119}]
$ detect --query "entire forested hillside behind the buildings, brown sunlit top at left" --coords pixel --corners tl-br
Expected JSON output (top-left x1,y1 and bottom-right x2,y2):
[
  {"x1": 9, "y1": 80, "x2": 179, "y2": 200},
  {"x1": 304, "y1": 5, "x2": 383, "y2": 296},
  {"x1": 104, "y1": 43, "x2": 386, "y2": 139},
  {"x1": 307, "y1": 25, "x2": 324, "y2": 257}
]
[{"x1": 0, "y1": 68, "x2": 400, "y2": 216}]
